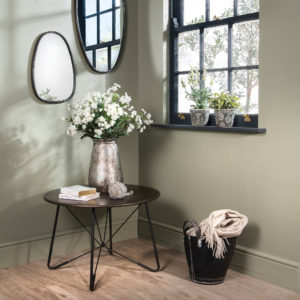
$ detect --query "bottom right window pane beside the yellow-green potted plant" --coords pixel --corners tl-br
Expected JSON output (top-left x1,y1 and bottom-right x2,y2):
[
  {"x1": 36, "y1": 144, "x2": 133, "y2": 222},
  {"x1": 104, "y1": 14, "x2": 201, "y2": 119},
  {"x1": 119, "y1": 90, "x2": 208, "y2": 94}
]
[{"x1": 232, "y1": 70, "x2": 258, "y2": 114}]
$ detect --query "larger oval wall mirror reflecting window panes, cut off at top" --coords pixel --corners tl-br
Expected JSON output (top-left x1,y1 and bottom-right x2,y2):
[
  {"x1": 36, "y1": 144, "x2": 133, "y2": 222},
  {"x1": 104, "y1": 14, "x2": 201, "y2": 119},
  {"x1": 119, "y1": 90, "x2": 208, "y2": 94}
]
[{"x1": 75, "y1": 0, "x2": 126, "y2": 73}]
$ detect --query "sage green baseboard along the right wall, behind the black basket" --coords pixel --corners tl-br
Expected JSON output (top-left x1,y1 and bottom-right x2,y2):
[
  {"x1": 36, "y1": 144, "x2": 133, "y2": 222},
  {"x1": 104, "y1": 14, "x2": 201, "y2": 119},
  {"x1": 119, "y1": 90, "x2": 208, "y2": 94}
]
[{"x1": 138, "y1": 217, "x2": 300, "y2": 292}]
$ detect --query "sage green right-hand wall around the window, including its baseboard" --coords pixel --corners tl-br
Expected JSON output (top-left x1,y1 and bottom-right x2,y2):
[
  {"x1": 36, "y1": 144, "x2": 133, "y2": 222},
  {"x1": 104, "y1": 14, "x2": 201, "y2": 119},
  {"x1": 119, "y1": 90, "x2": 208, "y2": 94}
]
[{"x1": 139, "y1": 0, "x2": 300, "y2": 291}]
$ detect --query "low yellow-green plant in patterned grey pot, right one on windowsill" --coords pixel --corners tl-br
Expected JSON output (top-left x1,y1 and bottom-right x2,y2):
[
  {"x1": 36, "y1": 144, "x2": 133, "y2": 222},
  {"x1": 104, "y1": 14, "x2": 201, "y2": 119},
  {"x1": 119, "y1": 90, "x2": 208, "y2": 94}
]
[{"x1": 209, "y1": 91, "x2": 240, "y2": 127}]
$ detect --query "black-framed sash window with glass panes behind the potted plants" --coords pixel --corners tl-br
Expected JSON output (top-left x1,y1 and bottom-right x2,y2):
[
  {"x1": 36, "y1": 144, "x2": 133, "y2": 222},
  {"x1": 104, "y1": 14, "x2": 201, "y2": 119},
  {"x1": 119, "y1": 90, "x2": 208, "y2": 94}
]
[{"x1": 170, "y1": 0, "x2": 259, "y2": 127}]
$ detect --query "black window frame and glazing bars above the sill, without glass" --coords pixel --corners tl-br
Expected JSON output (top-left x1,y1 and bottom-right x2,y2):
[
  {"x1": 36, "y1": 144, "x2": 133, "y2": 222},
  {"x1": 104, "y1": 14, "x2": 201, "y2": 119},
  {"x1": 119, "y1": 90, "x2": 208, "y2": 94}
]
[{"x1": 169, "y1": 0, "x2": 259, "y2": 128}]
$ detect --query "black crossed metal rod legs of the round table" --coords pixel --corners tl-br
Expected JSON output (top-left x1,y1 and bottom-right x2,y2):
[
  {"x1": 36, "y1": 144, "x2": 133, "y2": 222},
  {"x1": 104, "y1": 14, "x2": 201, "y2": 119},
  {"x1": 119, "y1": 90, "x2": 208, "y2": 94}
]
[{"x1": 47, "y1": 202, "x2": 160, "y2": 291}]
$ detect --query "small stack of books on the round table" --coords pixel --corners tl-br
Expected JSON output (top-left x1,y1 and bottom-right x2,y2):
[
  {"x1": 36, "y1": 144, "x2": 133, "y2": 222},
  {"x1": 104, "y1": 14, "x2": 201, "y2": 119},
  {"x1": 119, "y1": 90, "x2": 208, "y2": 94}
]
[{"x1": 59, "y1": 185, "x2": 100, "y2": 201}]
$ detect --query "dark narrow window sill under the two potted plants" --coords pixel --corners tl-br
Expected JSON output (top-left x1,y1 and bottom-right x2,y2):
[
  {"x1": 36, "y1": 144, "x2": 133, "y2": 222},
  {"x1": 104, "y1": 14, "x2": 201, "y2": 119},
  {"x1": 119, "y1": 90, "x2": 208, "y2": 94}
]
[{"x1": 151, "y1": 124, "x2": 267, "y2": 133}]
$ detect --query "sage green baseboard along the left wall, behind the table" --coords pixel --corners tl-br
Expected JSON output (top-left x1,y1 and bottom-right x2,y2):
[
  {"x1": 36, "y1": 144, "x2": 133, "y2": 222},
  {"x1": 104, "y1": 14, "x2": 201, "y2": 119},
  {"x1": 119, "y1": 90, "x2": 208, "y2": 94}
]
[{"x1": 0, "y1": 218, "x2": 138, "y2": 268}]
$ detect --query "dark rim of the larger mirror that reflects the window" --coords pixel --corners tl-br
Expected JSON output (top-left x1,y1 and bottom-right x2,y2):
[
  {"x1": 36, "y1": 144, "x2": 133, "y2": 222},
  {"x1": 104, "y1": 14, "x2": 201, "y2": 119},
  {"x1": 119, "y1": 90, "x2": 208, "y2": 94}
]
[{"x1": 74, "y1": 0, "x2": 127, "y2": 74}]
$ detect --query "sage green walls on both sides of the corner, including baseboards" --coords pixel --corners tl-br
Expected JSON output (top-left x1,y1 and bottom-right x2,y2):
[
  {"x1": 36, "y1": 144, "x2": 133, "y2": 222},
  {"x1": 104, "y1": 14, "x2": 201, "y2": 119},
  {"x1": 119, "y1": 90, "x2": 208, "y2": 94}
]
[{"x1": 0, "y1": 0, "x2": 300, "y2": 290}]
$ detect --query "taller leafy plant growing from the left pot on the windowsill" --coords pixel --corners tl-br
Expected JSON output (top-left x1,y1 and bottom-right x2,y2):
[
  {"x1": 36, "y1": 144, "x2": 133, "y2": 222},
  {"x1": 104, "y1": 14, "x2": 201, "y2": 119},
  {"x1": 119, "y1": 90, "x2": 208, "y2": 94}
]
[{"x1": 181, "y1": 69, "x2": 212, "y2": 109}]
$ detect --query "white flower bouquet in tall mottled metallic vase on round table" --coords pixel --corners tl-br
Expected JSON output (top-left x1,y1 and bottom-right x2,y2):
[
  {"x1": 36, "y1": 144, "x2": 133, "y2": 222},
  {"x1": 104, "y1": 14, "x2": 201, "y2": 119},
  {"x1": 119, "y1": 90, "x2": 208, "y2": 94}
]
[{"x1": 63, "y1": 83, "x2": 152, "y2": 192}]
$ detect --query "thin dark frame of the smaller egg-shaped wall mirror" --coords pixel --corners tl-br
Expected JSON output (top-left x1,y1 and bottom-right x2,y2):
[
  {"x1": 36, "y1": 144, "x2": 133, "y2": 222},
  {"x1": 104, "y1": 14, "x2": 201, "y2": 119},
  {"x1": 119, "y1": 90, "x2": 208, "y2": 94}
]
[{"x1": 31, "y1": 31, "x2": 76, "y2": 104}]
